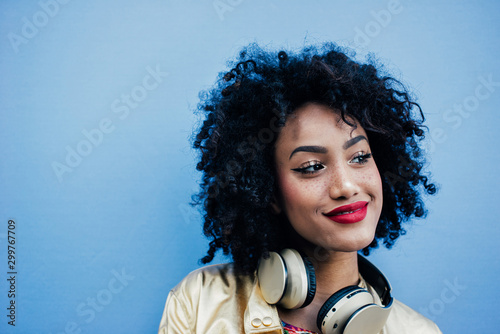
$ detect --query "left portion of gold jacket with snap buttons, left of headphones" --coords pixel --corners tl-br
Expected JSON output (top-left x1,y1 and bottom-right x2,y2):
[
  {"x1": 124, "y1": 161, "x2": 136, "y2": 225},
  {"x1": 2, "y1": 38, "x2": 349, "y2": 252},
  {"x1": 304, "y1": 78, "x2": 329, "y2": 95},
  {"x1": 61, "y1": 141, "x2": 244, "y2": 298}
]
[{"x1": 159, "y1": 263, "x2": 281, "y2": 334}]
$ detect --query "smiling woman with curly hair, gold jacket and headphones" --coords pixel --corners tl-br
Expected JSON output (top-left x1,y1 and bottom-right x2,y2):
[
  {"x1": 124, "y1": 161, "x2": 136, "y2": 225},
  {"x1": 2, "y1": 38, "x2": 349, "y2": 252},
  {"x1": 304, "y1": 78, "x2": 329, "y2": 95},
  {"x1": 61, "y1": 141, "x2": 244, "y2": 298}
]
[{"x1": 160, "y1": 44, "x2": 440, "y2": 334}]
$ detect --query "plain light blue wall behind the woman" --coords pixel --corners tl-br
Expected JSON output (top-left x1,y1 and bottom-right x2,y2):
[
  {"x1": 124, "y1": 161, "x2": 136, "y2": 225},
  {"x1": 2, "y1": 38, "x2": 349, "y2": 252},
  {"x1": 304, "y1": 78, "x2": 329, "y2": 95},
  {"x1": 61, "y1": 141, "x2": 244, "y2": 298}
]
[{"x1": 0, "y1": 0, "x2": 500, "y2": 333}]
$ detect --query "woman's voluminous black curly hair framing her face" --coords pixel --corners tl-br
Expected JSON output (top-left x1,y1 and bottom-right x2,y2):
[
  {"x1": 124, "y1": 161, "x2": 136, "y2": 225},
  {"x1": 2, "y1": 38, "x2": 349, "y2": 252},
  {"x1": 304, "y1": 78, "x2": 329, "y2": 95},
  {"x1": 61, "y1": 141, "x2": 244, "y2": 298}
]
[{"x1": 193, "y1": 43, "x2": 436, "y2": 273}]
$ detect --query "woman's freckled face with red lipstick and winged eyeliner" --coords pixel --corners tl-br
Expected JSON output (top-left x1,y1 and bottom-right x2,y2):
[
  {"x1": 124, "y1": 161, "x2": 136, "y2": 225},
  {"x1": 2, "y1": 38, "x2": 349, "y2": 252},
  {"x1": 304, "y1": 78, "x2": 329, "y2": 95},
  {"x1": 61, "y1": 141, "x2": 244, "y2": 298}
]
[{"x1": 273, "y1": 103, "x2": 382, "y2": 252}]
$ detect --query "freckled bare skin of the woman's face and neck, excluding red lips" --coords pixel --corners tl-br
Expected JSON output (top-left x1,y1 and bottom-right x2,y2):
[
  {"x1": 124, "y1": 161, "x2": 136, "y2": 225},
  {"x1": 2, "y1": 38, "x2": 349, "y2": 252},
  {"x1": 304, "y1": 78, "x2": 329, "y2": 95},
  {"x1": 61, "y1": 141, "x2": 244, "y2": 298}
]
[{"x1": 272, "y1": 104, "x2": 382, "y2": 332}]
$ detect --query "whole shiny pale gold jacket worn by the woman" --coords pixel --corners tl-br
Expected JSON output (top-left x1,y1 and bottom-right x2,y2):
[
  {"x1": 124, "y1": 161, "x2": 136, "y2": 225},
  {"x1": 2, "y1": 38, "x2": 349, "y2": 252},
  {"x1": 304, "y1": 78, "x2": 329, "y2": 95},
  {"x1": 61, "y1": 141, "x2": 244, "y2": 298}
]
[{"x1": 158, "y1": 264, "x2": 441, "y2": 334}]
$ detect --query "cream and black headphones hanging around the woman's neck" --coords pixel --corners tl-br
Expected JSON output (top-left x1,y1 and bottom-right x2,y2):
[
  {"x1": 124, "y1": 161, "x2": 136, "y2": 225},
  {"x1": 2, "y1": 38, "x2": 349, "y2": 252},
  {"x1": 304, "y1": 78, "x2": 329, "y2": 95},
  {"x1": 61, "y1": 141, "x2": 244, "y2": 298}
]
[{"x1": 257, "y1": 248, "x2": 392, "y2": 334}]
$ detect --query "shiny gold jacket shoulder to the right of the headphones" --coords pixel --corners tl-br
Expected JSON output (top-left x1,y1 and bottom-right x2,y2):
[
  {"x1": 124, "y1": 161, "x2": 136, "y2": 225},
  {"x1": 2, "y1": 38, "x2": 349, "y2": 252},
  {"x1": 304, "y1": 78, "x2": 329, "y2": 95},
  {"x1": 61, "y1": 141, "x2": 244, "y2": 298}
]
[{"x1": 384, "y1": 299, "x2": 442, "y2": 334}]
